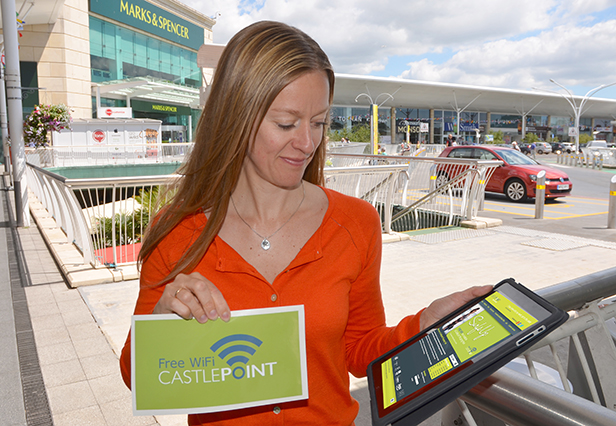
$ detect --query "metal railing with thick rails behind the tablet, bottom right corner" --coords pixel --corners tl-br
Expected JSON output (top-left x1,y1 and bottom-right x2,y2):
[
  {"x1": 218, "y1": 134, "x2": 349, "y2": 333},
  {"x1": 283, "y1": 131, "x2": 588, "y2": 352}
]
[{"x1": 454, "y1": 268, "x2": 616, "y2": 426}]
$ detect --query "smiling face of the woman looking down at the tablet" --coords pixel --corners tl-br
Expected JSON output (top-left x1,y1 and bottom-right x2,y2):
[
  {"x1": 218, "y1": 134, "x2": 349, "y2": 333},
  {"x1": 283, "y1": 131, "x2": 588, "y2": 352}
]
[{"x1": 243, "y1": 71, "x2": 329, "y2": 188}]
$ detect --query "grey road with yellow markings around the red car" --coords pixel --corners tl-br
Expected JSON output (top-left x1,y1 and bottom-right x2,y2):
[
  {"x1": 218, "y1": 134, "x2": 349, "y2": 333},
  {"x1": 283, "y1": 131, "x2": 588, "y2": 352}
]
[{"x1": 479, "y1": 154, "x2": 616, "y2": 242}]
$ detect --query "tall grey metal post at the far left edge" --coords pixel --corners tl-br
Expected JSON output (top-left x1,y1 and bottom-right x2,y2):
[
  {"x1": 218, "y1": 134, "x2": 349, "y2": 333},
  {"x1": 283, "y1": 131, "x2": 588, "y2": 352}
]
[{"x1": 2, "y1": 0, "x2": 30, "y2": 227}]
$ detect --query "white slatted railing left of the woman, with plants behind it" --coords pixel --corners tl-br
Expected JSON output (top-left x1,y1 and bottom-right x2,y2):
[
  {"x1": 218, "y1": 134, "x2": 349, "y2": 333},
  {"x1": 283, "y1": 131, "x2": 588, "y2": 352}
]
[{"x1": 26, "y1": 164, "x2": 178, "y2": 267}]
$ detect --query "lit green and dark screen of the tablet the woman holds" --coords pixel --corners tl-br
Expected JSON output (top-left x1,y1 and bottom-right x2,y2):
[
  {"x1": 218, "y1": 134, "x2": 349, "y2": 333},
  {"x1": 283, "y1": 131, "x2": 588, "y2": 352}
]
[{"x1": 375, "y1": 285, "x2": 550, "y2": 417}]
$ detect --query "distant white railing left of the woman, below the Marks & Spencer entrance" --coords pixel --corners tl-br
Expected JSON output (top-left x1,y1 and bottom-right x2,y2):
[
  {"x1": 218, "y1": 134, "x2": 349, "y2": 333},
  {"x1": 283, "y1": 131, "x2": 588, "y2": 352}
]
[{"x1": 26, "y1": 143, "x2": 193, "y2": 167}]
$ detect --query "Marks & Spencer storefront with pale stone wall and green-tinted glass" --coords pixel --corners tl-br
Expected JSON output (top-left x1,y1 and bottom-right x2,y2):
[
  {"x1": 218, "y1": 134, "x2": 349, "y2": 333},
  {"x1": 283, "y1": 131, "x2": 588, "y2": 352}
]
[{"x1": 18, "y1": 0, "x2": 216, "y2": 141}]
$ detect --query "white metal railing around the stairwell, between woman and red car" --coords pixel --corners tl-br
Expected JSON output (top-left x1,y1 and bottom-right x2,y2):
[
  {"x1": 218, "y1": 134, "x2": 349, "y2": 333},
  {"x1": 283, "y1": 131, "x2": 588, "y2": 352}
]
[{"x1": 325, "y1": 154, "x2": 502, "y2": 233}]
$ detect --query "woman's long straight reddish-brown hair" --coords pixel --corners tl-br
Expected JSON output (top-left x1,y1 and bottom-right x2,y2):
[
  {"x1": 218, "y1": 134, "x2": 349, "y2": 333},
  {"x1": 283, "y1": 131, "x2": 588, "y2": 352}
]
[{"x1": 139, "y1": 21, "x2": 334, "y2": 284}]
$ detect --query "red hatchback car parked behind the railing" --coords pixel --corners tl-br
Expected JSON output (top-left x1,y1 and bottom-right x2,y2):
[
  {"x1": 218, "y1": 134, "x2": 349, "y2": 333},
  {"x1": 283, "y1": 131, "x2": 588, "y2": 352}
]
[{"x1": 437, "y1": 145, "x2": 573, "y2": 201}]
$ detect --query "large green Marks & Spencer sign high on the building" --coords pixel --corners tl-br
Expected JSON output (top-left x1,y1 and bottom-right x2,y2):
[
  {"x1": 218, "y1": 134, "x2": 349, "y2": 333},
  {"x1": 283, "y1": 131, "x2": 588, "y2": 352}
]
[{"x1": 90, "y1": 0, "x2": 204, "y2": 50}]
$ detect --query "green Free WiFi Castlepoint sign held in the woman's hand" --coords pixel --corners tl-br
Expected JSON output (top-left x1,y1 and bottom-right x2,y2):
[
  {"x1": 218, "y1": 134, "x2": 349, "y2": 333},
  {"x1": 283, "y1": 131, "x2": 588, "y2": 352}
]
[{"x1": 131, "y1": 306, "x2": 308, "y2": 415}]
